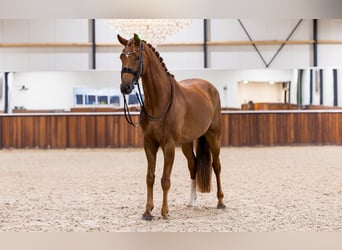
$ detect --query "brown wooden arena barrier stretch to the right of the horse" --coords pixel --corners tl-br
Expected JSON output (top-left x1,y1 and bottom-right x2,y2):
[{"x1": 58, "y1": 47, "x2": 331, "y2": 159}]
[{"x1": 222, "y1": 110, "x2": 342, "y2": 146}]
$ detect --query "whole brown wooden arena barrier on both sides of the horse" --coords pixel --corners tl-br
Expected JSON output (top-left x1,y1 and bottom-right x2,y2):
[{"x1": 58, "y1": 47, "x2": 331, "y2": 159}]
[{"x1": 0, "y1": 110, "x2": 342, "y2": 148}]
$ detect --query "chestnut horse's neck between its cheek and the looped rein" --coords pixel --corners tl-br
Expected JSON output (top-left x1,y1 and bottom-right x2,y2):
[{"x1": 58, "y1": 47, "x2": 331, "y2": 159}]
[{"x1": 142, "y1": 54, "x2": 173, "y2": 115}]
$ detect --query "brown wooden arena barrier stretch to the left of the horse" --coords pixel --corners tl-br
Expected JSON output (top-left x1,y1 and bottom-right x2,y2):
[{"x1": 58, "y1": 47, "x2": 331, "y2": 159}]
[{"x1": 0, "y1": 114, "x2": 142, "y2": 148}]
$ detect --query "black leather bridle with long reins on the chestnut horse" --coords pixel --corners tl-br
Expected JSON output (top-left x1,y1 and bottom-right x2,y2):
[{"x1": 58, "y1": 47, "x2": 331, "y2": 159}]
[{"x1": 121, "y1": 42, "x2": 174, "y2": 127}]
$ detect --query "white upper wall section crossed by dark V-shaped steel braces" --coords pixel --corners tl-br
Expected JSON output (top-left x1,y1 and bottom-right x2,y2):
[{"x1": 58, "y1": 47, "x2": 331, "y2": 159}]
[{"x1": 210, "y1": 19, "x2": 312, "y2": 69}]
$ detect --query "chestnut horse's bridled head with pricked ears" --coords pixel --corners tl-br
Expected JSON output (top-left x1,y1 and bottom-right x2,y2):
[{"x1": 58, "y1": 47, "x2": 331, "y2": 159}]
[{"x1": 118, "y1": 34, "x2": 144, "y2": 95}]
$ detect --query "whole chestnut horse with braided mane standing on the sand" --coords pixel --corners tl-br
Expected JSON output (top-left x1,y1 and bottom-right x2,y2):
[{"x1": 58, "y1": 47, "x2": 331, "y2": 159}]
[{"x1": 118, "y1": 34, "x2": 225, "y2": 220}]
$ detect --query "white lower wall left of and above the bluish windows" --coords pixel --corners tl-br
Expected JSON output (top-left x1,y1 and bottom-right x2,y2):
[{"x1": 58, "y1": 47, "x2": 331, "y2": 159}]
[{"x1": 9, "y1": 71, "x2": 120, "y2": 110}]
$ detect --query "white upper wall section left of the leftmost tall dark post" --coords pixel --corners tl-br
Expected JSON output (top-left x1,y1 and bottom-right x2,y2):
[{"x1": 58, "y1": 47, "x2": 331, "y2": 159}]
[{"x1": 0, "y1": 19, "x2": 90, "y2": 71}]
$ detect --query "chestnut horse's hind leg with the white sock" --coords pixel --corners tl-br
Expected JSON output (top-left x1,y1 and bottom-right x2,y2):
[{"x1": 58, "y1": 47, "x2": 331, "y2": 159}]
[{"x1": 182, "y1": 142, "x2": 197, "y2": 206}]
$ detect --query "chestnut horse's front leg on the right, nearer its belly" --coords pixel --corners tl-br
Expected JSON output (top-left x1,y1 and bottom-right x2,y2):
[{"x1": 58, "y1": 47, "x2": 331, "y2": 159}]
[{"x1": 161, "y1": 142, "x2": 175, "y2": 218}]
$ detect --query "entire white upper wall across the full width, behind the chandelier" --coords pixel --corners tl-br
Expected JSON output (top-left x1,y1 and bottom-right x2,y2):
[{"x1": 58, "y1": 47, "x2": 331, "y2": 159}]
[{"x1": 0, "y1": 19, "x2": 342, "y2": 72}]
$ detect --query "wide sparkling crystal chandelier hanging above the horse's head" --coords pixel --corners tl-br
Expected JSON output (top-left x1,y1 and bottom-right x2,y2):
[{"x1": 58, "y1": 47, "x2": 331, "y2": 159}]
[{"x1": 105, "y1": 19, "x2": 191, "y2": 46}]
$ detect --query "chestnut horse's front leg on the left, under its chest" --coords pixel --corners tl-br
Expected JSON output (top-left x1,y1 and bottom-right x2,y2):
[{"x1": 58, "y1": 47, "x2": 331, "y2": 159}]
[{"x1": 143, "y1": 138, "x2": 158, "y2": 220}]
